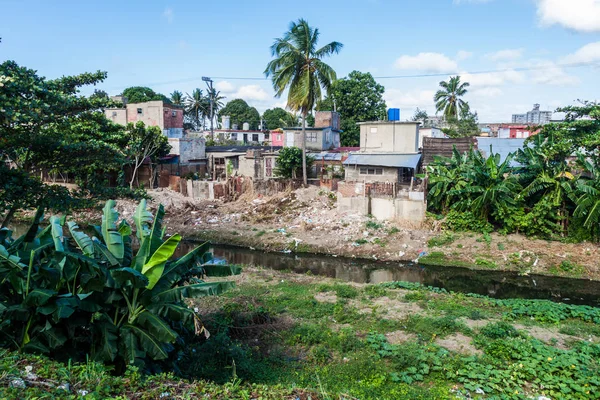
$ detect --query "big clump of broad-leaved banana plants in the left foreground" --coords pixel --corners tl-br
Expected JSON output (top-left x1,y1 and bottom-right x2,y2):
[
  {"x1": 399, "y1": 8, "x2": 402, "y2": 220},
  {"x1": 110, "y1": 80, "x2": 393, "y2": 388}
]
[{"x1": 0, "y1": 200, "x2": 240, "y2": 365}]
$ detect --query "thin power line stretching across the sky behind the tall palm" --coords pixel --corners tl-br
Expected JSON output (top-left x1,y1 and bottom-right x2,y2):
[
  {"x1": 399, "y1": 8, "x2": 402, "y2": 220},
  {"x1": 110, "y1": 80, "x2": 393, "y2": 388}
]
[{"x1": 104, "y1": 61, "x2": 600, "y2": 89}]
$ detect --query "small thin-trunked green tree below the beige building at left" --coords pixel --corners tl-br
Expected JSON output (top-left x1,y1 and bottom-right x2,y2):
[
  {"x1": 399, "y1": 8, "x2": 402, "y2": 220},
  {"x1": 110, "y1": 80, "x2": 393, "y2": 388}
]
[{"x1": 127, "y1": 121, "x2": 171, "y2": 189}]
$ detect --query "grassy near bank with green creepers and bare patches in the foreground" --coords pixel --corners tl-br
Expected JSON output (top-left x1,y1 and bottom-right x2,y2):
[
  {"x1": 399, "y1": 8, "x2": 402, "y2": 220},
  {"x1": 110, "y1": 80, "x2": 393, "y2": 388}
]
[{"x1": 0, "y1": 268, "x2": 600, "y2": 399}]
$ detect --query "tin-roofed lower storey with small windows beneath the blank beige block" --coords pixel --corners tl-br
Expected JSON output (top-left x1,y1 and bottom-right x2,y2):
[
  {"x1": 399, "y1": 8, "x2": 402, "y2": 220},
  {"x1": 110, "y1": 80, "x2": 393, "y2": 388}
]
[{"x1": 343, "y1": 153, "x2": 421, "y2": 185}]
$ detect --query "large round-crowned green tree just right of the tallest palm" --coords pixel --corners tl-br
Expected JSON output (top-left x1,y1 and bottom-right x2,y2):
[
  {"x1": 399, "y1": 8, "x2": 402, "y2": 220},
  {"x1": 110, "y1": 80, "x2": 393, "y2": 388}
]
[{"x1": 317, "y1": 71, "x2": 387, "y2": 146}]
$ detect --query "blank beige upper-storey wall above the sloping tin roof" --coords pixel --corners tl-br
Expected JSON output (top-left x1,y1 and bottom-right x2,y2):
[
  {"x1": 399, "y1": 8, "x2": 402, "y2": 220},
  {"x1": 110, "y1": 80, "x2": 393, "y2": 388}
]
[{"x1": 360, "y1": 121, "x2": 419, "y2": 154}]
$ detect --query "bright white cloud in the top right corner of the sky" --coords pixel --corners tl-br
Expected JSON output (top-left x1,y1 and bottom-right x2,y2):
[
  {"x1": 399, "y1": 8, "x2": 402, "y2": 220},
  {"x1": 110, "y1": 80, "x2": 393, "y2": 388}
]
[{"x1": 536, "y1": 0, "x2": 600, "y2": 32}]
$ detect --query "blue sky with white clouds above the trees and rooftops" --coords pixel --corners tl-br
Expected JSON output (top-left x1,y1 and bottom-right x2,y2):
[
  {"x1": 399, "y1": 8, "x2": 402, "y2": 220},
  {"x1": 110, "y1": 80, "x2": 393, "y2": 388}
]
[{"x1": 0, "y1": 0, "x2": 600, "y2": 122}]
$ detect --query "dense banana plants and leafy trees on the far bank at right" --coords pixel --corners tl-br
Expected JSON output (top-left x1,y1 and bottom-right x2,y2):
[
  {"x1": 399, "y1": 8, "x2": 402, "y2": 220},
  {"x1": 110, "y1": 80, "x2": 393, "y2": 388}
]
[{"x1": 427, "y1": 102, "x2": 600, "y2": 241}]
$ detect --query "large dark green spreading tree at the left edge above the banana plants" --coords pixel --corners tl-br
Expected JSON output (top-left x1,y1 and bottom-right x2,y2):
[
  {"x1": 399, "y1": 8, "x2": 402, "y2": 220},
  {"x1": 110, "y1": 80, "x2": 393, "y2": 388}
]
[{"x1": 0, "y1": 61, "x2": 127, "y2": 226}]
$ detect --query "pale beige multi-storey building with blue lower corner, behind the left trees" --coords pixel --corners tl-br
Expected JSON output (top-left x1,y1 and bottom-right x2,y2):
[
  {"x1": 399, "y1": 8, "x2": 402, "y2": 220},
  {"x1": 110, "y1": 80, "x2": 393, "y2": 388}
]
[{"x1": 104, "y1": 98, "x2": 183, "y2": 138}]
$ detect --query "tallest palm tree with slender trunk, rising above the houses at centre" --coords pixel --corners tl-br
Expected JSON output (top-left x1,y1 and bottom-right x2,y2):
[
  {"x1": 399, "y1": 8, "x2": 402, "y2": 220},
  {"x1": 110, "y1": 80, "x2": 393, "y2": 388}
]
[{"x1": 265, "y1": 19, "x2": 343, "y2": 186}]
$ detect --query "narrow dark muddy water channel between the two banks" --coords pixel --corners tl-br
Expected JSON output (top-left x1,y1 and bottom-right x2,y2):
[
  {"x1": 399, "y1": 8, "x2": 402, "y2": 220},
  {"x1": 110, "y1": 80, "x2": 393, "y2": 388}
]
[{"x1": 181, "y1": 242, "x2": 600, "y2": 306}]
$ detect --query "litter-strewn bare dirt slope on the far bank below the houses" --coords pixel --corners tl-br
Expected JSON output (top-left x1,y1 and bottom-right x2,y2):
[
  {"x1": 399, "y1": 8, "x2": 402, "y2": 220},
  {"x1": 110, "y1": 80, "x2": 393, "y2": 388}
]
[{"x1": 32, "y1": 187, "x2": 600, "y2": 280}]
